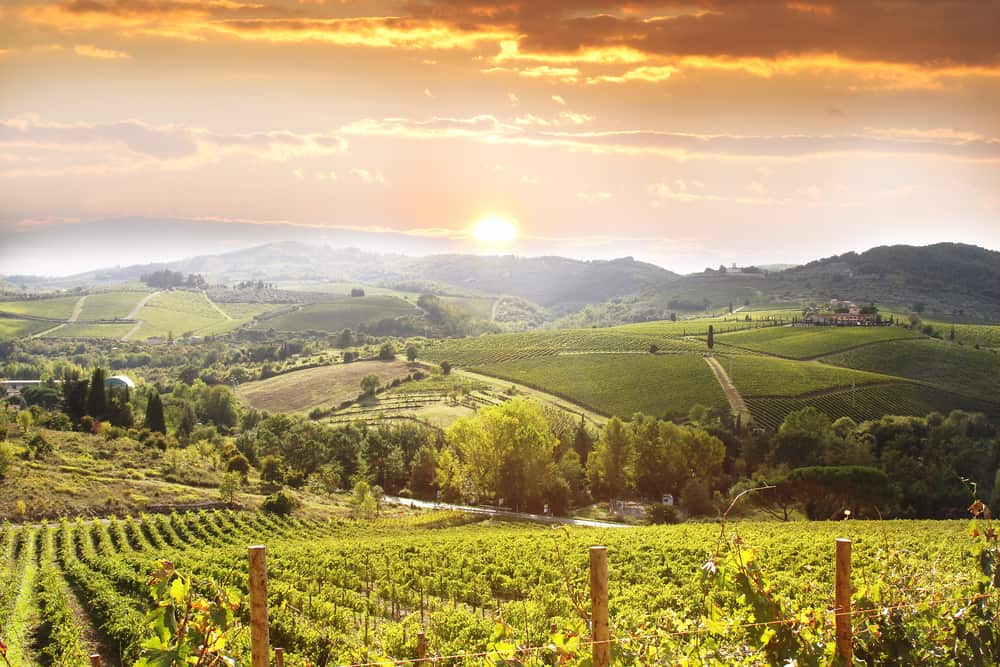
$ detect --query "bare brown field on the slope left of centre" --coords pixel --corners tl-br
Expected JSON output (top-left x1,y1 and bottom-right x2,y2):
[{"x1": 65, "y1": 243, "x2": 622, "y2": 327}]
[{"x1": 236, "y1": 361, "x2": 411, "y2": 412}]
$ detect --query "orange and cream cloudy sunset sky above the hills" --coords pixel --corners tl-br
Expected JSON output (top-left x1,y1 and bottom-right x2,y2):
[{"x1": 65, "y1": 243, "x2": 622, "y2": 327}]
[{"x1": 0, "y1": 0, "x2": 1000, "y2": 275}]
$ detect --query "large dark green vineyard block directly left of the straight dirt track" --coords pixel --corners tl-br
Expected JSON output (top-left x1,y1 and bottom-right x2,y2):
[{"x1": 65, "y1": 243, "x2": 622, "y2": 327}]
[{"x1": 470, "y1": 354, "x2": 728, "y2": 417}]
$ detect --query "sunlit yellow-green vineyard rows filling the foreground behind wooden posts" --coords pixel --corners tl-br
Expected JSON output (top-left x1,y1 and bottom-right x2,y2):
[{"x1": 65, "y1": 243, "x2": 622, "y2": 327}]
[{"x1": 0, "y1": 511, "x2": 995, "y2": 665}]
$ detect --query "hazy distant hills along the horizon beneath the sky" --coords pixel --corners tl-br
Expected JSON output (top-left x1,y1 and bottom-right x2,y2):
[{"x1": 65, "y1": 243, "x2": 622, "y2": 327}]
[{"x1": 5, "y1": 241, "x2": 1000, "y2": 326}]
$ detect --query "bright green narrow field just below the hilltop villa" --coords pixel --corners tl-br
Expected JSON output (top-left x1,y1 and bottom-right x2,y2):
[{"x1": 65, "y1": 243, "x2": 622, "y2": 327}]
[{"x1": 715, "y1": 327, "x2": 923, "y2": 359}]
